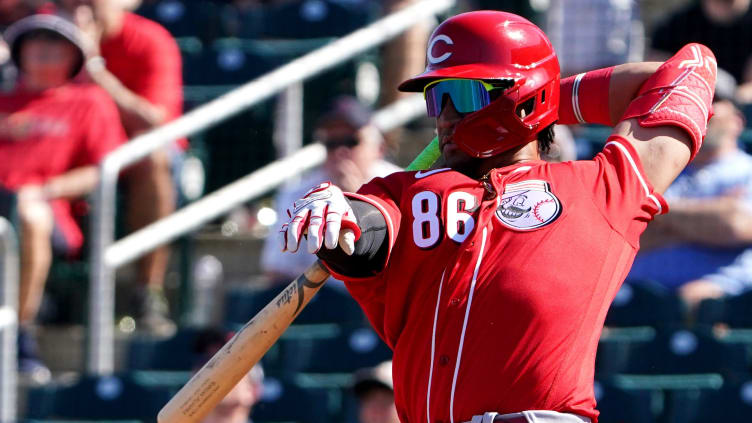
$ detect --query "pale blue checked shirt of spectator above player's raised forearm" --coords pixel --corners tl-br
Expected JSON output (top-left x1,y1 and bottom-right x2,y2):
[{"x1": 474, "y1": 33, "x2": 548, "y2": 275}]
[{"x1": 545, "y1": 0, "x2": 645, "y2": 77}]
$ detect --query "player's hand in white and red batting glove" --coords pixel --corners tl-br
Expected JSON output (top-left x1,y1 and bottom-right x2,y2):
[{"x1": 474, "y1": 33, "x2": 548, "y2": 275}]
[{"x1": 279, "y1": 182, "x2": 360, "y2": 255}]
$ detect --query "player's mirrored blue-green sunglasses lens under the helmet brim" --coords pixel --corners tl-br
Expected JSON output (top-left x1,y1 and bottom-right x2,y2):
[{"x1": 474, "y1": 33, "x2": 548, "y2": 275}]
[{"x1": 425, "y1": 79, "x2": 491, "y2": 117}]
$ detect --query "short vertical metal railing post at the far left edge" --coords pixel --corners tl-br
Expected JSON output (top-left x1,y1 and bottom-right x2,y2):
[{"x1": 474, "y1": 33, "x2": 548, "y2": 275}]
[{"x1": 0, "y1": 217, "x2": 19, "y2": 423}]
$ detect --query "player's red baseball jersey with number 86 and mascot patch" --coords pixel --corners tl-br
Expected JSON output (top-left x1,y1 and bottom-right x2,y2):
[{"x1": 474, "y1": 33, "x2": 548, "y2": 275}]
[{"x1": 326, "y1": 137, "x2": 668, "y2": 423}]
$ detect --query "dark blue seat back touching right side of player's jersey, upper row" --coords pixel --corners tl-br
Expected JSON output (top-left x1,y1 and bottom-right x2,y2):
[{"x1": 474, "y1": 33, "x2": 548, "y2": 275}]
[{"x1": 606, "y1": 281, "x2": 682, "y2": 327}]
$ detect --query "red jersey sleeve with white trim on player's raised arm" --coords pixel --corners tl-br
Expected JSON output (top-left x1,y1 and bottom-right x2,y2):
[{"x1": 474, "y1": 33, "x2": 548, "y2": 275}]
[{"x1": 574, "y1": 136, "x2": 668, "y2": 248}]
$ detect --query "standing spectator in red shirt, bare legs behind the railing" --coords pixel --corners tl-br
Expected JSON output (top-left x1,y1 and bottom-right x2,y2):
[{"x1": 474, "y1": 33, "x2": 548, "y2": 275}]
[{"x1": 61, "y1": 0, "x2": 186, "y2": 334}]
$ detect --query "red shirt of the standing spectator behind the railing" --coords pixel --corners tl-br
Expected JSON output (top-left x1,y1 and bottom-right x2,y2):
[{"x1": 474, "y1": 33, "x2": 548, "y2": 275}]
[{"x1": 100, "y1": 13, "x2": 187, "y2": 147}]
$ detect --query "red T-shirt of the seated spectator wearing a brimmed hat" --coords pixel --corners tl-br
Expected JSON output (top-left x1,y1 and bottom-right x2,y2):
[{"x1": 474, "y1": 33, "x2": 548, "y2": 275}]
[{"x1": 0, "y1": 84, "x2": 125, "y2": 250}]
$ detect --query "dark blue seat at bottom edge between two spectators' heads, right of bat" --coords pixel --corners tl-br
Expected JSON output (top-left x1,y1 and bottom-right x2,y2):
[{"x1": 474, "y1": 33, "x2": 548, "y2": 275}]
[{"x1": 251, "y1": 377, "x2": 338, "y2": 423}]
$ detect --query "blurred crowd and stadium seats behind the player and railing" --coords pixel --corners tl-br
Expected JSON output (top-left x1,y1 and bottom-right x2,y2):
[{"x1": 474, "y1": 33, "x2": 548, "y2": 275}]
[{"x1": 0, "y1": 0, "x2": 752, "y2": 423}]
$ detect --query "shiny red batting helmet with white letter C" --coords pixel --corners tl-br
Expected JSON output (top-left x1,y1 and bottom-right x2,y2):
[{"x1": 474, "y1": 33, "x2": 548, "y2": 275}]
[{"x1": 399, "y1": 11, "x2": 560, "y2": 157}]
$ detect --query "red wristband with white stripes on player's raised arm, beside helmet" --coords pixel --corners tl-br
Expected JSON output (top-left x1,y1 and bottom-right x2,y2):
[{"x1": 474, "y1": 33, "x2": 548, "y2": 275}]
[{"x1": 559, "y1": 66, "x2": 614, "y2": 126}]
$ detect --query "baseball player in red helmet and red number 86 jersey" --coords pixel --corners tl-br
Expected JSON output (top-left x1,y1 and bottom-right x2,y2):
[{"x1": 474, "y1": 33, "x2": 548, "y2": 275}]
[{"x1": 281, "y1": 11, "x2": 716, "y2": 423}]
